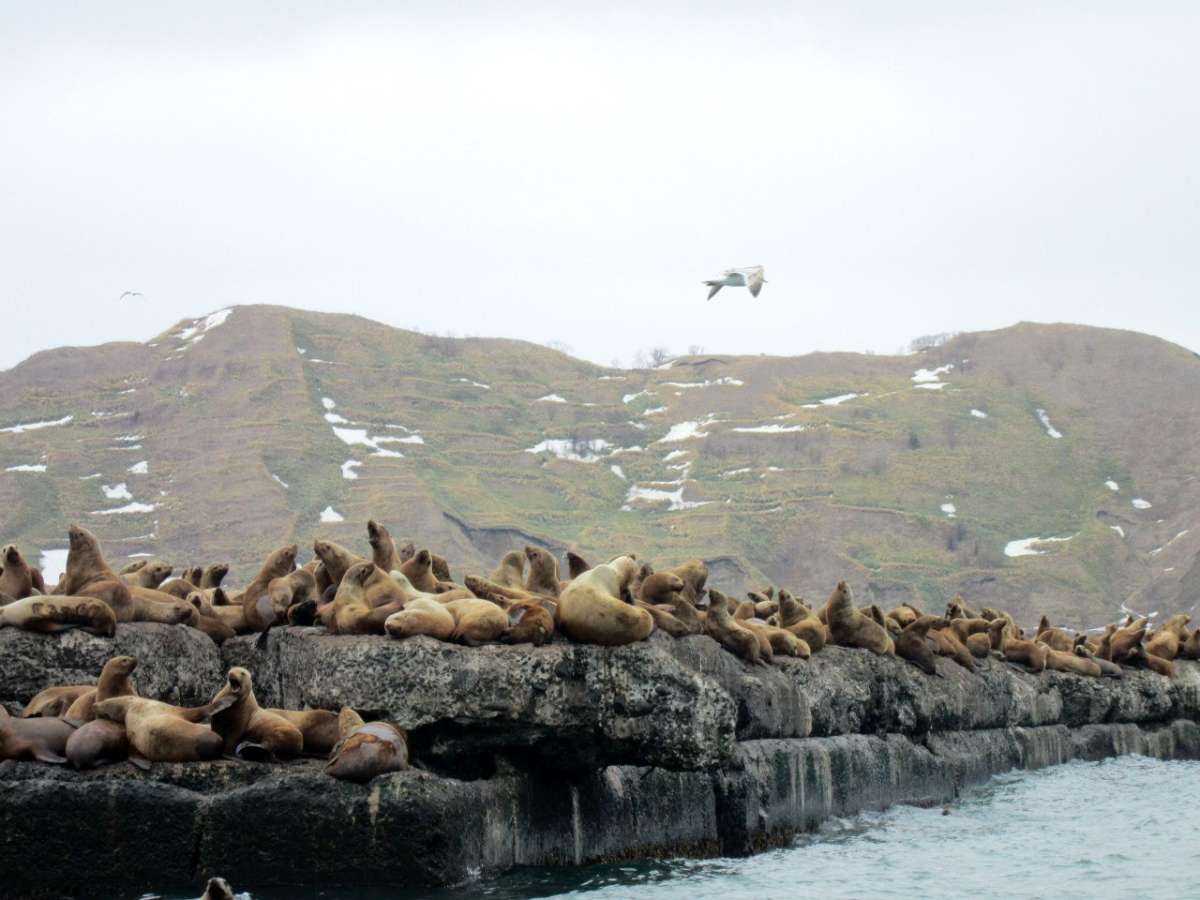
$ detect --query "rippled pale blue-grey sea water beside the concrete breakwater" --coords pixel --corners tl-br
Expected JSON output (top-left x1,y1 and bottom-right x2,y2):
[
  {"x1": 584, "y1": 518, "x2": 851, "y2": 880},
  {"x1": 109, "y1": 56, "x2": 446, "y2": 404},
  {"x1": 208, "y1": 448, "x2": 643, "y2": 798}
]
[{"x1": 148, "y1": 756, "x2": 1200, "y2": 900}]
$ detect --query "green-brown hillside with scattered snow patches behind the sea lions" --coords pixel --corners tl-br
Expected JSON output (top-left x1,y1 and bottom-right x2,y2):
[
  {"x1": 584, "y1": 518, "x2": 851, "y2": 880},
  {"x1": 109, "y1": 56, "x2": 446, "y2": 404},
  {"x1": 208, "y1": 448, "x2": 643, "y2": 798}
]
[{"x1": 0, "y1": 306, "x2": 1200, "y2": 626}]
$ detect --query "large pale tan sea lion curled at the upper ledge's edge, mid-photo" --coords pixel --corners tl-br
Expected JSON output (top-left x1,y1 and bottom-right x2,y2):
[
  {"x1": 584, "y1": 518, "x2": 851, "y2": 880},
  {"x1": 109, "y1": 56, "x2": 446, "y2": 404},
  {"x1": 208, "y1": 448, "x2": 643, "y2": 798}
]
[{"x1": 556, "y1": 548, "x2": 654, "y2": 647}]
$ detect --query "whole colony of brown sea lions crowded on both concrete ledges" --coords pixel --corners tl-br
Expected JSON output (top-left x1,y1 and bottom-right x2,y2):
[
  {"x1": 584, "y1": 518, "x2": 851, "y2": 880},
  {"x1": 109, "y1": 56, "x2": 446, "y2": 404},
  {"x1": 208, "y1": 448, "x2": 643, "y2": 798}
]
[{"x1": 0, "y1": 521, "x2": 1200, "y2": 782}]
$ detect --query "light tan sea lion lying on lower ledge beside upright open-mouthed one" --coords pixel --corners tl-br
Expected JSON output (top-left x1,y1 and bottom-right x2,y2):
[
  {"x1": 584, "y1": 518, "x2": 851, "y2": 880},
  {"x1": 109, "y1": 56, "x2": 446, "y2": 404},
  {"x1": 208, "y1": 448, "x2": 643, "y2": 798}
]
[{"x1": 95, "y1": 696, "x2": 234, "y2": 767}]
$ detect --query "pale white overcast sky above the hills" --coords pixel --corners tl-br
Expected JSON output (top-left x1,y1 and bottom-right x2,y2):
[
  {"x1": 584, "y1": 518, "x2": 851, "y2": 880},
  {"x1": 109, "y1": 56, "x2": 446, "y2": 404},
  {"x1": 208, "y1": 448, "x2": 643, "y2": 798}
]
[{"x1": 0, "y1": 0, "x2": 1200, "y2": 368}]
